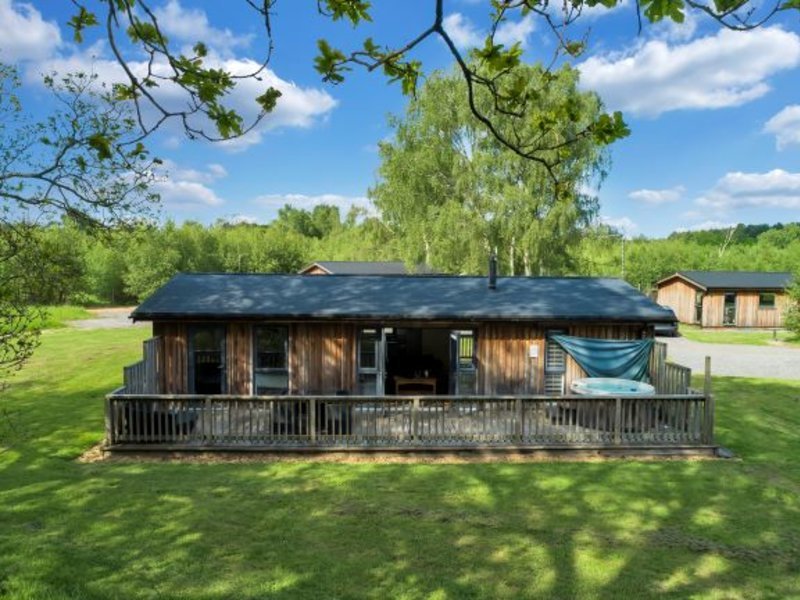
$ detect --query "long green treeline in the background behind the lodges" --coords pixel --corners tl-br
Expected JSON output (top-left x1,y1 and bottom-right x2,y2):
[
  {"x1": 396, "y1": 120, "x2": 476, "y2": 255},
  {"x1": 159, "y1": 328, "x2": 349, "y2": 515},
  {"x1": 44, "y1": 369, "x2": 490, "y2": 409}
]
[{"x1": 17, "y1": 212, "x2": 800, "y2": 305}]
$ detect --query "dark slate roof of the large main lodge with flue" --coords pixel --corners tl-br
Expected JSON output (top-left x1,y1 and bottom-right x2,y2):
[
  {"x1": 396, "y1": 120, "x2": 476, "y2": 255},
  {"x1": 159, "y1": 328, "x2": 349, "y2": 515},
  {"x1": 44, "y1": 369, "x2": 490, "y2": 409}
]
[{"x1": 131, "y1": 273, "x2": 675, "y2": 321}]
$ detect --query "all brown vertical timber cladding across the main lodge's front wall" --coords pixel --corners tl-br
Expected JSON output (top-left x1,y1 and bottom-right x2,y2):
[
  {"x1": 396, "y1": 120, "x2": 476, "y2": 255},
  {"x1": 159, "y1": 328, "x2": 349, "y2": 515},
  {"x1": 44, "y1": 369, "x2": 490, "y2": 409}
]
[{"x1": 153, "y1": 322, "x2": 650, "y2": 396}]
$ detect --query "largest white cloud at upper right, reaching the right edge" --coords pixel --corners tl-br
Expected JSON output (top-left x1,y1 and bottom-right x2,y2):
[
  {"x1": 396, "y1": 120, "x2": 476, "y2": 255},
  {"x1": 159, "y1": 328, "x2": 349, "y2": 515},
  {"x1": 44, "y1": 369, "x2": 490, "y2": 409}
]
[{"x1": 578, "y1": 27, "x2": 800, "y2": 116}]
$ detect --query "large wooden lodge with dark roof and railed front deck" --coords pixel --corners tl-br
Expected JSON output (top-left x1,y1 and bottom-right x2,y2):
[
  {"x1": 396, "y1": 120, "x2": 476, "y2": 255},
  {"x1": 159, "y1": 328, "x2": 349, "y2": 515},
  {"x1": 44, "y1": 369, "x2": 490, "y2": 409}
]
[{"x1": 106, "y1": 274, "x2": 713, "y2": 453}]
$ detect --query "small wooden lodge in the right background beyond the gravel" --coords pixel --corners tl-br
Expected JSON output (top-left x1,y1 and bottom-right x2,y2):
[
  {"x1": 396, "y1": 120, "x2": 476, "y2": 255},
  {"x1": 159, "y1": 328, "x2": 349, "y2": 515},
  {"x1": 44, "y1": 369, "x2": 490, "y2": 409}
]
[{"x1": 656, "y1": 271, "x2": 792, "y2": 328}]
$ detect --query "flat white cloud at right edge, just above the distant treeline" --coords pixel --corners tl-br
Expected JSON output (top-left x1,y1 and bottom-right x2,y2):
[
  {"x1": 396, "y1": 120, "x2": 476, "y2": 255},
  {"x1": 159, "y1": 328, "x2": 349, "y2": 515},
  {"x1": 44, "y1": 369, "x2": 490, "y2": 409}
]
[{"x1": 697, "y1": 169, "x2": 800, "y2": 210}]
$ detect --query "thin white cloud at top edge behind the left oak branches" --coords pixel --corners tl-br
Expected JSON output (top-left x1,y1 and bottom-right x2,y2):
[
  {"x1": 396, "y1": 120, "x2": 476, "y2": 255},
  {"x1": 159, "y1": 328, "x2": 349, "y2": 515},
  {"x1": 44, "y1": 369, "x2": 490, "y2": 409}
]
[{"x1": 154, "y1": 0, "x2": 253, "y2": 55}]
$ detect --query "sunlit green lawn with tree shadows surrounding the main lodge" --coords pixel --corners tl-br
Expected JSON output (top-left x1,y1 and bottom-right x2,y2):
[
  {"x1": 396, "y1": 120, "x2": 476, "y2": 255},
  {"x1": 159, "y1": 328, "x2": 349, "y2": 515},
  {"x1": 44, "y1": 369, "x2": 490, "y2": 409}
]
[{"x1": 0, "y1": 329, "x2": 800, "y2": 599}]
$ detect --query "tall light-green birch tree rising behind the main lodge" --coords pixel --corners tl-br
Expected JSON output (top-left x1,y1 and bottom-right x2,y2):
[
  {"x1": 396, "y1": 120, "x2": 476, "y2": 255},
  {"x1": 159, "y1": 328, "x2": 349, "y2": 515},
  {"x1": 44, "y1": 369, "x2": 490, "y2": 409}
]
[{"x1": 370, "y1": 66, "x2": 607, "y2": 275}]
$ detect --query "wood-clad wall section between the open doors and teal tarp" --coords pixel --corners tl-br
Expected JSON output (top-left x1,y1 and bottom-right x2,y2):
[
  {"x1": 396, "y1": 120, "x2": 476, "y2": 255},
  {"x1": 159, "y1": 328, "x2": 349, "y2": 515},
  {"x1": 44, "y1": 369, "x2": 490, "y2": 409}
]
[{"x1": 477, "y1": 323, "x2": 544, "y2": 396}]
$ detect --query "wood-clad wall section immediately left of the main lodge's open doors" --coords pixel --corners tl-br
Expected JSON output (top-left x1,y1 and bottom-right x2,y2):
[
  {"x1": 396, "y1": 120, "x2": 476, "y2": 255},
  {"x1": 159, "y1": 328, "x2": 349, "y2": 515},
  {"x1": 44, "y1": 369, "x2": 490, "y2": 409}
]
[{"x1": 289, "y1": 323, "x2": 356, "y2": 394}]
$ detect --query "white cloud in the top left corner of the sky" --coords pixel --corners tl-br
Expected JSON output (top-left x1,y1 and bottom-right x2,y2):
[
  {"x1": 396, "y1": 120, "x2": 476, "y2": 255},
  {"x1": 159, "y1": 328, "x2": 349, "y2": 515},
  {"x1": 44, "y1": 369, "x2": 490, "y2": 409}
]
[{"x1": 0, "y1": 0, "x2": 61, "y2": 63}]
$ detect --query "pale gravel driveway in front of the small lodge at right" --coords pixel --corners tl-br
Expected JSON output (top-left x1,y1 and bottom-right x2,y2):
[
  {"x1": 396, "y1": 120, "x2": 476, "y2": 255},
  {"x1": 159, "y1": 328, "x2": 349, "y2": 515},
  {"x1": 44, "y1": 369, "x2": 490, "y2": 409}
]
[{"x1": 658, "y1": 337, "x2": 800, "y2": 379}]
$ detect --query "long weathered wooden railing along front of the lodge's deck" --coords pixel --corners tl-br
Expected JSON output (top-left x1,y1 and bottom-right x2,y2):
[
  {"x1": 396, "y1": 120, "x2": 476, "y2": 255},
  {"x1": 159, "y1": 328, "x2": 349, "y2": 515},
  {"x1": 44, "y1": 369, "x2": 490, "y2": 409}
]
[{"x1": 106, "y1": 393, "x2": 713, "y2": 449}]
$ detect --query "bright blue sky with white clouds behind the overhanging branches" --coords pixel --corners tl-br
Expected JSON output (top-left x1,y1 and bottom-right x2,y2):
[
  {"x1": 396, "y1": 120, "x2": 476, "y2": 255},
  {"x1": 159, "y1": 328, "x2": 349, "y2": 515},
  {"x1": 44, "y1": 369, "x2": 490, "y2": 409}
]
[{"x1": 0, "y1": 0, "x2": 800, "y2": 236}]
